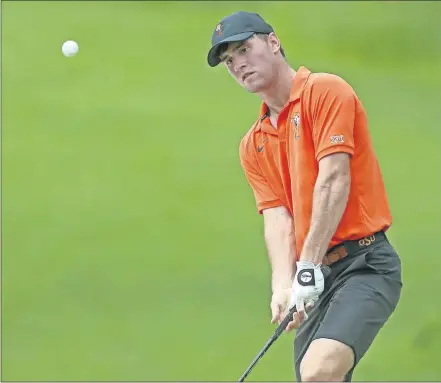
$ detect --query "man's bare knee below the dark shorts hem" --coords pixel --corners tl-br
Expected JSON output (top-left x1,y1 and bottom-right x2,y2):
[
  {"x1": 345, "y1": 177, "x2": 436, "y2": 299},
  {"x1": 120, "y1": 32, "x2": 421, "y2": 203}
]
[{"x1": 300, "y1": 339, "x2": 354, "y2": 382}]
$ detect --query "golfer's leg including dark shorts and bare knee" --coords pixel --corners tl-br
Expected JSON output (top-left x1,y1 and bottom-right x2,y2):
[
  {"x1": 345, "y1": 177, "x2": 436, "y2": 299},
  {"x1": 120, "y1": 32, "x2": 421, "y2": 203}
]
[{"x1": 294, "y1": 241, "x2": 401, "y2": 382}]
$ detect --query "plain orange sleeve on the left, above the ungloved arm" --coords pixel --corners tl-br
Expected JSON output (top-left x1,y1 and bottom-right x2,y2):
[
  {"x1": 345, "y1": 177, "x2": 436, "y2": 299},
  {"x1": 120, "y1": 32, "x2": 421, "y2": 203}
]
[{"x1": 239, "y1": 139, "x2": 282, "y2": 214}]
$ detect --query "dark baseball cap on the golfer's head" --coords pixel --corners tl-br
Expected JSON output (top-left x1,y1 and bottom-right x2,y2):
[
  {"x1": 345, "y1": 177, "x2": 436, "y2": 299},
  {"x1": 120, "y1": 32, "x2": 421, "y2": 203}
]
[{"x1": 207, "y1": 11, "x2": 274, "y2": 67}]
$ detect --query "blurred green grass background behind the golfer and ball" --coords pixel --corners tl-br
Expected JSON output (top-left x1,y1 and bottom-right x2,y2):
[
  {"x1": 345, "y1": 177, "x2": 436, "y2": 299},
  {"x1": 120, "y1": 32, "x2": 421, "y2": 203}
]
[{"x1": 1, "y1": 1, "x2": 441, "y2": 381}]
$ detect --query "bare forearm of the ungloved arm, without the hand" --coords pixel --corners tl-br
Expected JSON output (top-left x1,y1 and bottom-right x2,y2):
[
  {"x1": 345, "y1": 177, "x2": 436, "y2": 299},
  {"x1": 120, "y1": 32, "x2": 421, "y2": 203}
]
[{"x1": 264, "y1": 209, "x2": 296, "y2": 292}]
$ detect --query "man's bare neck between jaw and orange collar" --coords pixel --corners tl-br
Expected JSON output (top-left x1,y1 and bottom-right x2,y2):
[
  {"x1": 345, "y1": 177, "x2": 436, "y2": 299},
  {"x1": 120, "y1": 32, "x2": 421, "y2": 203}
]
[{"x1": 260, "y1": 63, "x2": 296, "y2": 115}]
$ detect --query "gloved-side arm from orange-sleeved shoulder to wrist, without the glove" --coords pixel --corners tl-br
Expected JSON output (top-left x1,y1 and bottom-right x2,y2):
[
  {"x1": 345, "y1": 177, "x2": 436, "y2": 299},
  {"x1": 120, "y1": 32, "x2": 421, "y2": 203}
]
[{"x1": 300, "y1": 75, "x2": 357, "y2": 264}]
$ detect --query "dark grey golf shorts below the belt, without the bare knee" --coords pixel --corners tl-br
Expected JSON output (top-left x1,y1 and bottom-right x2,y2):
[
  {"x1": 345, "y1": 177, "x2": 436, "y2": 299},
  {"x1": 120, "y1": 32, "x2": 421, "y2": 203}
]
[{"x1": 294, "y1": 234, "x2": 402, "y2": 381}]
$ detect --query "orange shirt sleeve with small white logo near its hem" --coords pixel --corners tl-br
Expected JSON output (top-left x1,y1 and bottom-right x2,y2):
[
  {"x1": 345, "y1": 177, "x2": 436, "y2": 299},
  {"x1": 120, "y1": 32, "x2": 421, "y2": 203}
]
[{"x1": 311, "y1": 74, "x2": 357, "y2": 161}]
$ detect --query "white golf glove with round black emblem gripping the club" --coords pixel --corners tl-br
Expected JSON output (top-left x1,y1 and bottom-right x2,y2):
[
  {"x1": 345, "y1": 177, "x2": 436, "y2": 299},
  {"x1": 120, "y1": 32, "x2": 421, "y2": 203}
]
[{"x1": 289, "y1": 261, "x2": 325, "y2": 320}]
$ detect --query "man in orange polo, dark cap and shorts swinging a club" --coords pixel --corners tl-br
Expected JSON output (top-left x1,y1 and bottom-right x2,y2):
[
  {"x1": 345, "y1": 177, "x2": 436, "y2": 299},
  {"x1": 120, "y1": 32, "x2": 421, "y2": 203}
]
[{"x1": 208, "y1": 12, "x2": 402, "y2": 382}]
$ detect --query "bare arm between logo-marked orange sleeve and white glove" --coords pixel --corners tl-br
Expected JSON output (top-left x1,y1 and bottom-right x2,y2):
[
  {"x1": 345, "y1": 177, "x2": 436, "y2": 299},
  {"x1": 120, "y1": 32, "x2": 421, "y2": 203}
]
[{"x1": 300, "y1": 153, "x2": 351, "y2": 264}]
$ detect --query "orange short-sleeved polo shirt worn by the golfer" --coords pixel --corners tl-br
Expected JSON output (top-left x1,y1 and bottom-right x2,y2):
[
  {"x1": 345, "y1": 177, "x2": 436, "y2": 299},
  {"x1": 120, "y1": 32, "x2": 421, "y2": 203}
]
[{"x1": 239, "y1": 67, "x2": 392, "y2": 254}]
